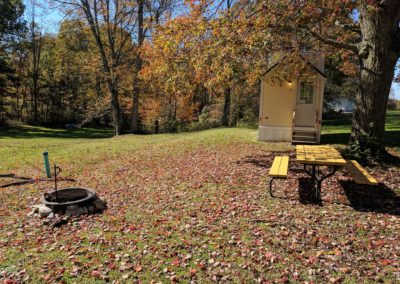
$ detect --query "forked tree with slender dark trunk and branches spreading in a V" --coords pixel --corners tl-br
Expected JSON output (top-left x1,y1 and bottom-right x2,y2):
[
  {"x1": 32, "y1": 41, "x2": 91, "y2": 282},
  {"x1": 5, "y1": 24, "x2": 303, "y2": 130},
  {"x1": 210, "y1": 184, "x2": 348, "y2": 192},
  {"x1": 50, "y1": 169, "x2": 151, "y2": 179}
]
[{"x1": 56, "y1": 0, "x2": 141, "y2": 136}]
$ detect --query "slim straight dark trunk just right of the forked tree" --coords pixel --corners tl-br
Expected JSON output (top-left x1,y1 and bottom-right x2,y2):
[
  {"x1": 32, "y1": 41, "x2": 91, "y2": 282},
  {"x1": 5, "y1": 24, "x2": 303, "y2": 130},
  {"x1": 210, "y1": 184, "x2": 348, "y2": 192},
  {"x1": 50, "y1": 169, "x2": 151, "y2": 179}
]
[{"x1": 131, "y1": 0, "x2": 144, "y2": 133}]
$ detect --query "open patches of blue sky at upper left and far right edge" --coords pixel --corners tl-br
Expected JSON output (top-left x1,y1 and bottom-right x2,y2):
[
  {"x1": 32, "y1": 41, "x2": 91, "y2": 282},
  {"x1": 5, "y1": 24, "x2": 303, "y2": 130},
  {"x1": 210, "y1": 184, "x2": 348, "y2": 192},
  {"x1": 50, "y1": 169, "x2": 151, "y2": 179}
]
[{"x1": 24, "y1": 0, "x2": 400, "y2": 100}]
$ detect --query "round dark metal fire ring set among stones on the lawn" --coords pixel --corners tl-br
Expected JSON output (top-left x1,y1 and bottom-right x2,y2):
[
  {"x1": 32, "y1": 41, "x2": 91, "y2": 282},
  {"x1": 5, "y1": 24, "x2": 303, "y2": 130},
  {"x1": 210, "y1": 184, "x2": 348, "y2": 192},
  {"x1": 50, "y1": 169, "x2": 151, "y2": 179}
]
[{"x1": 42, "y1": 187, "x2": 97, "y2": 210}]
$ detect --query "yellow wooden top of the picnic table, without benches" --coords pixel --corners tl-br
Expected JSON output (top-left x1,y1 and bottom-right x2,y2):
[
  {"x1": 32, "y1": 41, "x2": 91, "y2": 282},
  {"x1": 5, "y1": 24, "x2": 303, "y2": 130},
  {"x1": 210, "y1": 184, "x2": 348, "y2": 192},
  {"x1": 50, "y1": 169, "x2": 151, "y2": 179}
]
[{"x1": 296, "y1": 145, "x2": 346, "y2": 166}]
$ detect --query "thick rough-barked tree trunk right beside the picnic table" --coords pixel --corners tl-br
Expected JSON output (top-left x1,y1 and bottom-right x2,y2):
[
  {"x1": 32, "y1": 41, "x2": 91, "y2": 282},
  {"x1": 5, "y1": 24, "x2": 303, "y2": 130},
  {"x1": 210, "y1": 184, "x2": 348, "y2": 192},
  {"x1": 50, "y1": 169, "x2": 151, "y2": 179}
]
[{"x1": 351, "y1": 0, "x2": 400, "y2": 154}]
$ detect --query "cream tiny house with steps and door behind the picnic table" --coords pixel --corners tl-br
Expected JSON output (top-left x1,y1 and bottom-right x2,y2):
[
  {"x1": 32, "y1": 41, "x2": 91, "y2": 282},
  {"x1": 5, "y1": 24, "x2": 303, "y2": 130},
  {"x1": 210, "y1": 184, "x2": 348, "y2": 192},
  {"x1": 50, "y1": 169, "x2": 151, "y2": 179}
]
[{"x1": 258, "y1": 52, "x2": 326, "y2": 144}]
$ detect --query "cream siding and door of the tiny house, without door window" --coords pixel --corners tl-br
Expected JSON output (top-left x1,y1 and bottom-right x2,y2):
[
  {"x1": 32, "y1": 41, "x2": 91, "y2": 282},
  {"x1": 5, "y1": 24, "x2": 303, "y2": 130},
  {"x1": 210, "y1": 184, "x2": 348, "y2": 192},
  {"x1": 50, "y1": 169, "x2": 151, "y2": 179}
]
[{"x1": 258, "y1": 56, "x2": 325, "y2": 143}]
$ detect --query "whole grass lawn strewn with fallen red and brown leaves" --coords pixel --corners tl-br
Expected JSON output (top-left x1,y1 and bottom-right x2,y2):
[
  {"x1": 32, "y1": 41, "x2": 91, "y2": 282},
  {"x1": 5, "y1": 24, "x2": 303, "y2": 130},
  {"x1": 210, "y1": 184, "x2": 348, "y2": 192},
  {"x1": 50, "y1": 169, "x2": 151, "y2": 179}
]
[{"x1": 0, "y1": 111, "x2": 400, "y2": 283}]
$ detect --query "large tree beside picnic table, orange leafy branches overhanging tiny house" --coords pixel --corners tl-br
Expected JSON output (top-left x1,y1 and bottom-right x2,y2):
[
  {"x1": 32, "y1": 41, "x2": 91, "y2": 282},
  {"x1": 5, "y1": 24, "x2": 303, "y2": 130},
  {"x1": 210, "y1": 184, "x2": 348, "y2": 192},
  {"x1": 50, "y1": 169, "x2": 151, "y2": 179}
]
[{"x1": 249, "y1": 0, "x2": 400, "y2": 153}]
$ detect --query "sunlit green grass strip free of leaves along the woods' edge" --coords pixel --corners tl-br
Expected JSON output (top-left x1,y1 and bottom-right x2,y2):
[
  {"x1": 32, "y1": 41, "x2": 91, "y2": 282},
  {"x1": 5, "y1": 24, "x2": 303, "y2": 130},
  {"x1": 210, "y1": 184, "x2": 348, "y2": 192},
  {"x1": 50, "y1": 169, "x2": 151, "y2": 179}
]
[{"x1": 0, "y1": 126, "x2": 268, "y2": 175}]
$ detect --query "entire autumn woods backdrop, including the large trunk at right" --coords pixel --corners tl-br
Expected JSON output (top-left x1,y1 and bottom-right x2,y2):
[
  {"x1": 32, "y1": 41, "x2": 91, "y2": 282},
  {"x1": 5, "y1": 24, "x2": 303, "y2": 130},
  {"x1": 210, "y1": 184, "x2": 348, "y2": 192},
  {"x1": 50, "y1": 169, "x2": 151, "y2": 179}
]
[{"x1": 0, "y1": 0, "x2": 400, "y2": 149}]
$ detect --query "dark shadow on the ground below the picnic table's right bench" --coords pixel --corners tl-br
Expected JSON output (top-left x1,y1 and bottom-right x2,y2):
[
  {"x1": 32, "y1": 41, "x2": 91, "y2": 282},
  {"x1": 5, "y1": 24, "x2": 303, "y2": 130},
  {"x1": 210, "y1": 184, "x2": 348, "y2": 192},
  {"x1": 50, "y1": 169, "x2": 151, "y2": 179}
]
[{"x1": 340, "y1": 181, "x2": 400, "y2": 216}]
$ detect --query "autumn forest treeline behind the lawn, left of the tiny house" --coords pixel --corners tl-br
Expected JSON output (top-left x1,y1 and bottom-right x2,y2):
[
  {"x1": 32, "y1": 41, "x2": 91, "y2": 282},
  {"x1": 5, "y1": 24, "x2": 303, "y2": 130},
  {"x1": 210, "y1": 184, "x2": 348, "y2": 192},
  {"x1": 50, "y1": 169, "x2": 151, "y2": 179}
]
[{"x1": 0, "y1": 0, "x2": 351, "y2": 132}]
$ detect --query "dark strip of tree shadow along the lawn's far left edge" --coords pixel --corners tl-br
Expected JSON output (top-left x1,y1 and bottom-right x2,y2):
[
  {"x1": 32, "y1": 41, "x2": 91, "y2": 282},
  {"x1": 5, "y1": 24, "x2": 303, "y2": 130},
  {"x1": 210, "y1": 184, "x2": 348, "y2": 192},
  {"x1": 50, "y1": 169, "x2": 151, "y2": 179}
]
[{"x1": 0, "y1": 126, "x2": 113, "y2": 139}]
